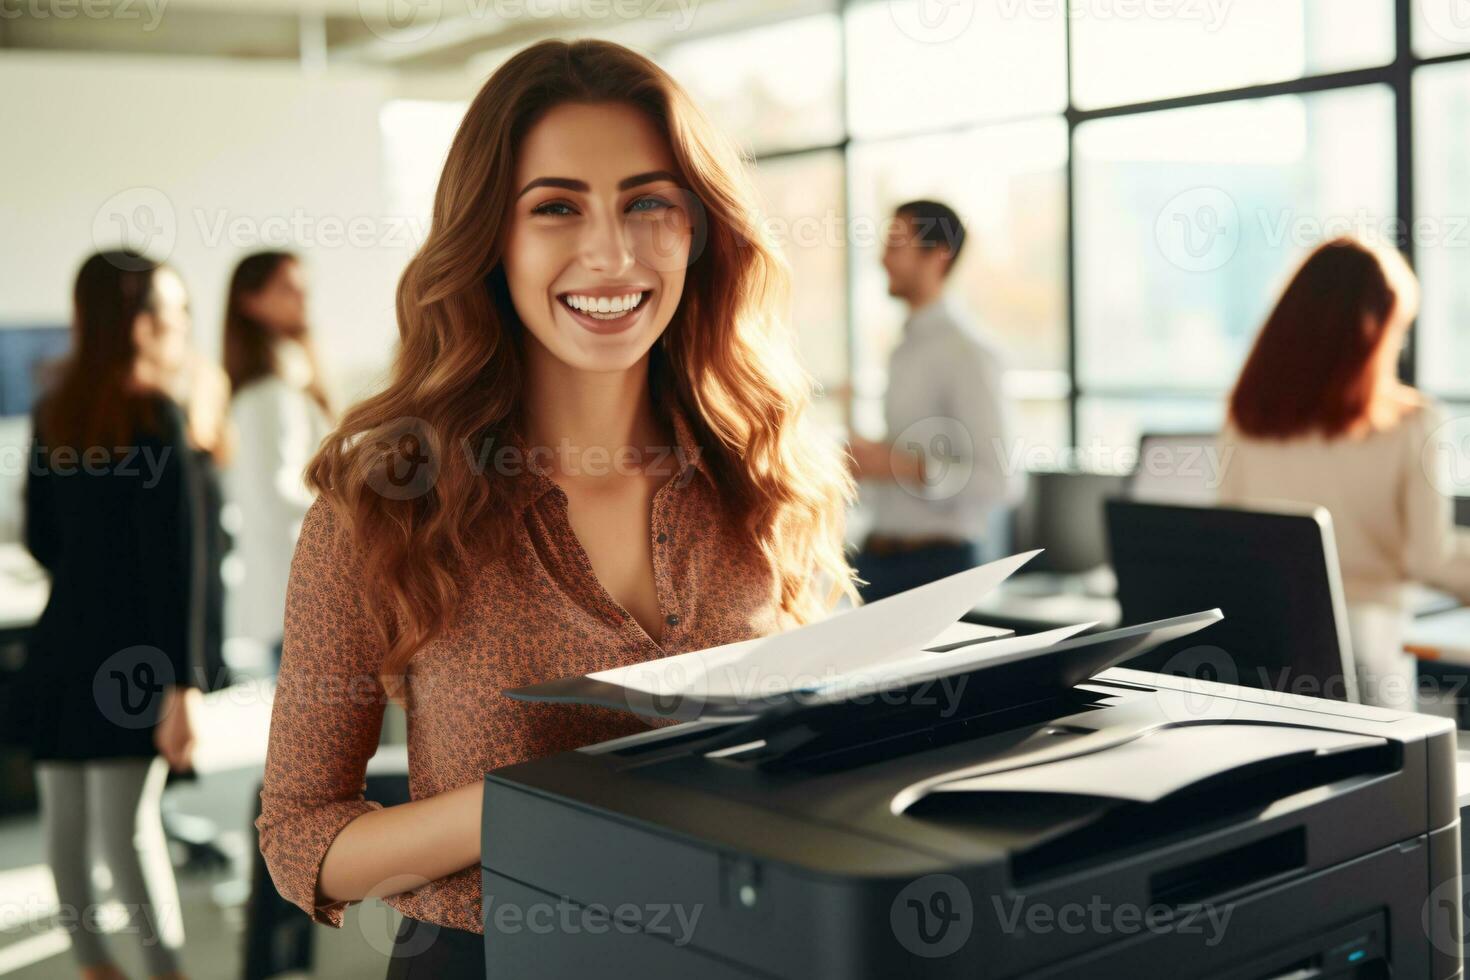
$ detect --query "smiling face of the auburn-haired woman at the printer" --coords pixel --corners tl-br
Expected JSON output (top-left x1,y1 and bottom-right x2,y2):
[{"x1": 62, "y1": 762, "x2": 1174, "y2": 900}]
[{"x1": 504, "y1": 103, "x2": 694, "y2": 372}]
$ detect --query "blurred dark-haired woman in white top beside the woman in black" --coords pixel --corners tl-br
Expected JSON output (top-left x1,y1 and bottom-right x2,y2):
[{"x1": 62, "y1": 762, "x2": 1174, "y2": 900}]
[{"x1": 225, "y1": 251, "x2": 331, "y2": 663}]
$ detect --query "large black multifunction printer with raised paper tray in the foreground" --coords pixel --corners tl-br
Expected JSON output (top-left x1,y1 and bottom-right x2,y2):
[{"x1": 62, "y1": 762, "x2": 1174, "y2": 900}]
[{"x1": 482, "y1": 613, "x2": 1461, "y2": 980}]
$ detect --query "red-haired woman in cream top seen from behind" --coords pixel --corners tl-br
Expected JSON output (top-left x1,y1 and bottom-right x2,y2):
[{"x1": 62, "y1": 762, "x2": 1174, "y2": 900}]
[{"x1": 1220, "y1": 238, "x2": 1470, "y2": 708}]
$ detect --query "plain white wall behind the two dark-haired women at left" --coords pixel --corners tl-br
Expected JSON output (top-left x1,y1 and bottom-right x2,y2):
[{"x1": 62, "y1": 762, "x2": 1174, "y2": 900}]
[{"x1": 0, "y1": 51, "x2": 412, "y2": 398}]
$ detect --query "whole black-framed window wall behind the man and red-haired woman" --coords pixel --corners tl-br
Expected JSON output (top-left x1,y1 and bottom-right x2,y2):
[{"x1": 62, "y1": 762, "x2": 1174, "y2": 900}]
[{"x1": 629, "y1": 0, "x2": 1470, "y2": 461}]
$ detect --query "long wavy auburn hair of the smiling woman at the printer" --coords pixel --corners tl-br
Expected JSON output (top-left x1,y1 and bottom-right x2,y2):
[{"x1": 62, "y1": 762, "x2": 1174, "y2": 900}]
[{"x1": 307, "y1": 41, "x2": 857, "y2": 698}]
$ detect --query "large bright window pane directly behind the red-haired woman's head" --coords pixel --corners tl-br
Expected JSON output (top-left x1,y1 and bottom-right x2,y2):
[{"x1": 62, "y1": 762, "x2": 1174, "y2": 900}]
[{"x1": 1076, "y1": 85, "x2": 1395, "y2": 394}]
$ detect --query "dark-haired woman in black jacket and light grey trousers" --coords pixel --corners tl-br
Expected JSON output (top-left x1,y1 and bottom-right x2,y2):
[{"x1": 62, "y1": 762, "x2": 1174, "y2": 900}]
[{"x1": 21, "y1": 251, "x2": 203, "y2": 980}]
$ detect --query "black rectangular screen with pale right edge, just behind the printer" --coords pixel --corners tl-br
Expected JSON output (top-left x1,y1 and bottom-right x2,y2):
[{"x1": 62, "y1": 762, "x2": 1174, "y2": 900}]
[{"x1": 1105, "y1": 500, "x2": 1358, "y2": 701}]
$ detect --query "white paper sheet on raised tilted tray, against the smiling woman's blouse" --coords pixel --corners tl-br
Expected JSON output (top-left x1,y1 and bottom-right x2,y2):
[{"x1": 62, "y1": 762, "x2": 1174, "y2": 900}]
[{"x1": 588, "y1": 551, "x2": 1041, "y2": 699}]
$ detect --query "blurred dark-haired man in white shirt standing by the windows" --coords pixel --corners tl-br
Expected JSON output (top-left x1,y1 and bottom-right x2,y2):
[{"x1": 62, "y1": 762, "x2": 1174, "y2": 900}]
[{"x1": 850, "y1": 201, "x2": 1025, "y2": 601}]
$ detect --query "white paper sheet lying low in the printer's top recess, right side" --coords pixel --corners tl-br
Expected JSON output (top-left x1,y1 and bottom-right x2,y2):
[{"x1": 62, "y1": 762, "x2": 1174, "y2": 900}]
[{"x1": 931, "y1": 724, "x2": 1383, "y2": 802}]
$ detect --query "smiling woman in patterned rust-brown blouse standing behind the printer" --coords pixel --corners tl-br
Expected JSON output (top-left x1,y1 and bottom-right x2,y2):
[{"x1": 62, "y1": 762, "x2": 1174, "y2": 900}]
[{"x1": 257, "y1": 41, "x2": 856, "y2": 977}]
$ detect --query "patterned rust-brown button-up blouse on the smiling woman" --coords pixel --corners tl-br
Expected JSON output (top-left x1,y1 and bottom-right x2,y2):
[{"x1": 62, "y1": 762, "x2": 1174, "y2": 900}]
[{"x1": 256, "y1": 406, "x2": 789, "y2": 933}]
